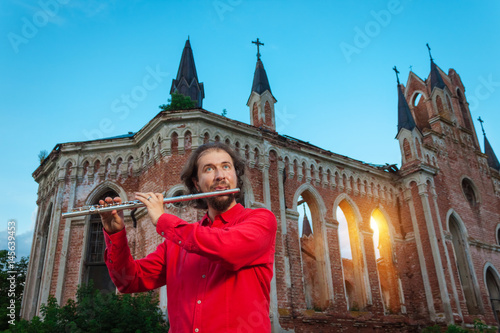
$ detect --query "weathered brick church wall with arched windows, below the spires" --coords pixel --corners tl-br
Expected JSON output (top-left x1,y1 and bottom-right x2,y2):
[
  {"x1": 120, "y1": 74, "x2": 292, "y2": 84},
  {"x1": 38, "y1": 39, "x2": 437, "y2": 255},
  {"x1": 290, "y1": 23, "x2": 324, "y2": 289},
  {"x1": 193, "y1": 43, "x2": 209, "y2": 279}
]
[{"x1": 23, "y1": 110, "x2": 500, "y2": 332}]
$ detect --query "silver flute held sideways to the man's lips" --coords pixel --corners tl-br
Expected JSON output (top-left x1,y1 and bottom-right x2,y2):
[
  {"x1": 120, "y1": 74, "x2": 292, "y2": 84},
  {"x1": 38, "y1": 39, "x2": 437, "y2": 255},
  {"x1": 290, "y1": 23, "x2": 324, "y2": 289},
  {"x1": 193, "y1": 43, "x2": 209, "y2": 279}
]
[{"x1": 62, "y1": 188, "x2": 240, "y2": 218}]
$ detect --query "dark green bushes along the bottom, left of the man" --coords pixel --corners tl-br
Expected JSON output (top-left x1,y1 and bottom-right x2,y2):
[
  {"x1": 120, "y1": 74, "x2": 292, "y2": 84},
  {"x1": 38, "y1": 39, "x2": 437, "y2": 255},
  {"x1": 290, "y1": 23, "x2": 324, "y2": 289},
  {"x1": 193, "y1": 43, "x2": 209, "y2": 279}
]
[{"x1": 2, "y1": 282, "x2": 169, "y2": 333}]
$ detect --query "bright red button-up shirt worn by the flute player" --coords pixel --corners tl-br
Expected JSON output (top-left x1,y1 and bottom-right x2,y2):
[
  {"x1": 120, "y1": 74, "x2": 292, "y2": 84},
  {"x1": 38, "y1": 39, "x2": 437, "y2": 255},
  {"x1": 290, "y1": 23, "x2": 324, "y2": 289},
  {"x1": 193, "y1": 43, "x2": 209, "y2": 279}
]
[{"x1": 104, "y1": 204, "x2": 277, "y2": 333}]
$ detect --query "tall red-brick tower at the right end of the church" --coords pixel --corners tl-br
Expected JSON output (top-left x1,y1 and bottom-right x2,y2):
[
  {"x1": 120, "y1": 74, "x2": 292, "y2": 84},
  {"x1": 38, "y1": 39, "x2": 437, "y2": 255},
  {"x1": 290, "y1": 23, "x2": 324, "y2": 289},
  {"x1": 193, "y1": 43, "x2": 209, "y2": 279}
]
[{"x1": 396, "y1": 45, "x2": 500, "y2": 323}]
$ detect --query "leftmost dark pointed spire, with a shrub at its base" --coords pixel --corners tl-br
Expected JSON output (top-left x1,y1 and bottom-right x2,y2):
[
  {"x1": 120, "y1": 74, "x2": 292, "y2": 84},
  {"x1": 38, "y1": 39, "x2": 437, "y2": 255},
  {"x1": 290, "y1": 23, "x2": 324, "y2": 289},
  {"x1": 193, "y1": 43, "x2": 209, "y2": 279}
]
[{"x1": 170, "y1": 36, "x2": 205, "y2": 108}]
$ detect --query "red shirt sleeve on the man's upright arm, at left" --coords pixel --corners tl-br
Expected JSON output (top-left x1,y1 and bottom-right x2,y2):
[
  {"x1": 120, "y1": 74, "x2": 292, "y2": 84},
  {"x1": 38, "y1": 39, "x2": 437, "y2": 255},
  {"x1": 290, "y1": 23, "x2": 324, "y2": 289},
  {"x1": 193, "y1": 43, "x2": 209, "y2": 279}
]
[{"x1": 103, "y1": 229, "x2": 167, "y2": 294}]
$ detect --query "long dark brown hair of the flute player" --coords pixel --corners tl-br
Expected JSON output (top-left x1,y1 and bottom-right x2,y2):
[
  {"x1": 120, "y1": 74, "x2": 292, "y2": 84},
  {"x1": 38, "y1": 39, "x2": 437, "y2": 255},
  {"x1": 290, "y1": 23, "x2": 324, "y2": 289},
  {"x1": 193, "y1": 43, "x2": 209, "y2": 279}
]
[{"x1": 181, "y1": 142, "x2": 245, "y2": 209}]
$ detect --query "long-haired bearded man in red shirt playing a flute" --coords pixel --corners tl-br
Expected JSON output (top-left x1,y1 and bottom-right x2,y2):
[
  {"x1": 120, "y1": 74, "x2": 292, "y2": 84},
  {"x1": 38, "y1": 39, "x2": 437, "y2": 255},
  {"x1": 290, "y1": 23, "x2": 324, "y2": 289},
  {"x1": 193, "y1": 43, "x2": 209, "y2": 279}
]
[{"x1": 101, "y1": 142, "x2": 277, "y2": 333}]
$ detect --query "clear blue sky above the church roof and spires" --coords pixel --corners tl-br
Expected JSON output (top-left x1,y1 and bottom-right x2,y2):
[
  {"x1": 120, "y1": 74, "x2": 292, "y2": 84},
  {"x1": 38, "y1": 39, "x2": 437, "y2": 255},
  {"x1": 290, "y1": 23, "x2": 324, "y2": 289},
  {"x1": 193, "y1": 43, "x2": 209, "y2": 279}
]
[{"x1": 0, "y1": 0, "x2": 500, "y2": 255}]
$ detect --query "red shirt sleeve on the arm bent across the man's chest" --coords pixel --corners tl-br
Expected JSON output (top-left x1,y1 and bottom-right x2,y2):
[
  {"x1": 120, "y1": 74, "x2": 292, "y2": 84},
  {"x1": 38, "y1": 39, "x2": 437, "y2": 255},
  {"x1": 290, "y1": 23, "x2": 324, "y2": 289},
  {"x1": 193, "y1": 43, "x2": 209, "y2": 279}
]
[{"x1": 156, "y1": 208, "x2": 277, "y2": 271}]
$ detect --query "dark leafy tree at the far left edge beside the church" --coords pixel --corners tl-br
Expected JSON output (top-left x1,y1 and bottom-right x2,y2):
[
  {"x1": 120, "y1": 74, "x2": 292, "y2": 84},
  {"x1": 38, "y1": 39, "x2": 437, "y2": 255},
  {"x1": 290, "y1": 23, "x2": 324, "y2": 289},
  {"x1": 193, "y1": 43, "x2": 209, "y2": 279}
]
[{"x1": 0, "y1": 250, "x2": 28, "y2": 331}]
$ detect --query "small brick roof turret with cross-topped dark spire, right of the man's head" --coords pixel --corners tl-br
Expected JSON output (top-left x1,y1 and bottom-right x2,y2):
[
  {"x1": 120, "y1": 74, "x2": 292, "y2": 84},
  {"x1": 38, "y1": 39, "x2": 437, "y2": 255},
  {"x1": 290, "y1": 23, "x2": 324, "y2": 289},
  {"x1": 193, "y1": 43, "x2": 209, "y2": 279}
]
[{"x1": 247, "y1": 38, "x2": 277, "y2": 131}]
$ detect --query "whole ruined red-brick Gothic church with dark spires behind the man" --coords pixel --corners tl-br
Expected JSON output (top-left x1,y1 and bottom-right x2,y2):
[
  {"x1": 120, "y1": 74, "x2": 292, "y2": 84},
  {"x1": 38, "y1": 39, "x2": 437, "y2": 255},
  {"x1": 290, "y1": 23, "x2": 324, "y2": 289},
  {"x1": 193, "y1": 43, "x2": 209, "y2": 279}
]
[{"x1": 21, "y1": 40, "x2": 500, "y2": 332}]
